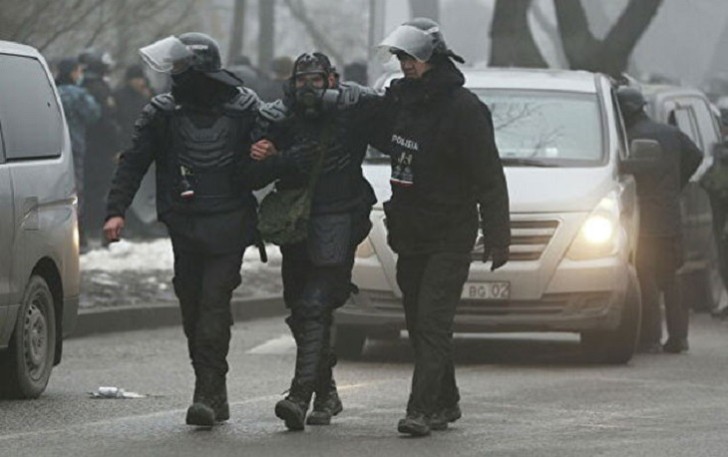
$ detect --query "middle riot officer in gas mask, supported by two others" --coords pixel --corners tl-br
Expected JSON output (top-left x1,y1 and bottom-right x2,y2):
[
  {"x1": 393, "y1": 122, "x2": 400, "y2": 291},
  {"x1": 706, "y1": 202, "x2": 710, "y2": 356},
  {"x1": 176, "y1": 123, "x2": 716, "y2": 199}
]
[{"x1": 251, "y1": 53, "x2": 380, "y2": 430}]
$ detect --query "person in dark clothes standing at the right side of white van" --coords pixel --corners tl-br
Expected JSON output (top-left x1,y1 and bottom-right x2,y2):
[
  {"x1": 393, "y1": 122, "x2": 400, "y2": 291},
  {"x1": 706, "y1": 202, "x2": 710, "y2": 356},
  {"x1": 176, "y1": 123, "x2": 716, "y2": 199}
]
[{"x1": 617, "y1": 87, "x2": 702, "y2": 353}]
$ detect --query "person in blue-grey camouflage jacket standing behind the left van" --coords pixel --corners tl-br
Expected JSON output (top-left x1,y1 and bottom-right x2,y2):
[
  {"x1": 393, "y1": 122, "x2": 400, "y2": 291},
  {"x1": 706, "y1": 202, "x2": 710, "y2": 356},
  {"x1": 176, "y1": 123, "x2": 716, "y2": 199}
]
[{"x1": 56, "y1": 58, "x2": 101, "y2": 251}]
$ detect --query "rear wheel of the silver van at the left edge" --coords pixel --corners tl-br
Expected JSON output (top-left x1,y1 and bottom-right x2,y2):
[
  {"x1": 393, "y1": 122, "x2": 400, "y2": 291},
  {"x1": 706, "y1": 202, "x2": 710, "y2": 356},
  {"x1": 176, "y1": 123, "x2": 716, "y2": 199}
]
[{"x1": 0, "y1": 276, "x2": 56, "y2": 398}]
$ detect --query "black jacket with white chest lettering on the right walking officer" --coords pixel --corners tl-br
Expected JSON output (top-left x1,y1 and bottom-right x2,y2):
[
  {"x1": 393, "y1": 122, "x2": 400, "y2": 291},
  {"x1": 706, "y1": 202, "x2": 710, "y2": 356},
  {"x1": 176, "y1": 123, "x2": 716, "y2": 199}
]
[{"x1": 375, "y1": 60, "x2": 510, "y2": 254}]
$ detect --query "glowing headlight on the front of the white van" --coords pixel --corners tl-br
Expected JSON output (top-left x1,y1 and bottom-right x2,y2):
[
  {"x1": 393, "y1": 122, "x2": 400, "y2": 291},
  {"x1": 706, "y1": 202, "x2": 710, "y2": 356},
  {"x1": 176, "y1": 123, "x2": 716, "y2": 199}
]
[{"x1": 566, "y1": 192, "x2": 620, "y2": 260}]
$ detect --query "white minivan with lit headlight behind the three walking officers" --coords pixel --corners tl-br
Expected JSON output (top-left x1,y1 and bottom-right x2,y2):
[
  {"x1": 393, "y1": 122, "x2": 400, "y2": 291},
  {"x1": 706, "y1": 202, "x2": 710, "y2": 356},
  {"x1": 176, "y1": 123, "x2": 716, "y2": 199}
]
[{"x1": 335, "y1": 69, "x2": 656, "y2": 363}]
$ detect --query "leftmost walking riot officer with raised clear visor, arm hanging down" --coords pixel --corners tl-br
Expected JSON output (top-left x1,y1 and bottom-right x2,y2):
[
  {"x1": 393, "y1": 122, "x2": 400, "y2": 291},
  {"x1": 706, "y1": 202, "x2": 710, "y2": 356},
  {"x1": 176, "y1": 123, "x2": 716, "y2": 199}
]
[{"x1": 104, "y1": 33, "x2": 266, "y2": 426}]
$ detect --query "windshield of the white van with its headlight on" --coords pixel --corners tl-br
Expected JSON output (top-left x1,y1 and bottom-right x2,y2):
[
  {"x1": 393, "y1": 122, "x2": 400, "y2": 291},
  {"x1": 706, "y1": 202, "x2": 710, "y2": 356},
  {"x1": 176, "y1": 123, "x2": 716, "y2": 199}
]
[{"x1": 471, "y1": 89, "x2": 604, "y2": 167}]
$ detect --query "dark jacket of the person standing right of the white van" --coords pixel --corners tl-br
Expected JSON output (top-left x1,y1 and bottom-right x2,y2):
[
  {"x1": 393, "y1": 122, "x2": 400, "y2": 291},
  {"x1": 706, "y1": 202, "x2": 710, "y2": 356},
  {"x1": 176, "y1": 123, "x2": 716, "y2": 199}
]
[{"x1": 627, "y1": 114, "x2": 702, "y2": 237}]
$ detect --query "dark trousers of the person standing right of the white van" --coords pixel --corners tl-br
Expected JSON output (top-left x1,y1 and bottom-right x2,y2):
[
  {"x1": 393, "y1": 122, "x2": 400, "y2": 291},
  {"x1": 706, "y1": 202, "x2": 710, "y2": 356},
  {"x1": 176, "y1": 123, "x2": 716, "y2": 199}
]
[{"x1": 637, "y1": 236, "x2": 689, "y2": 344}]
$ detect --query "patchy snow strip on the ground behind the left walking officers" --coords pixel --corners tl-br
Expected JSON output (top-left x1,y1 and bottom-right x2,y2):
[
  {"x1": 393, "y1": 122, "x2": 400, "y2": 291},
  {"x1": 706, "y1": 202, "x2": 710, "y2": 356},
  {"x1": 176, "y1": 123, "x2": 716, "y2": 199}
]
[{"x1": 80, "y1": 238, "x2": 282, "y2": 309}]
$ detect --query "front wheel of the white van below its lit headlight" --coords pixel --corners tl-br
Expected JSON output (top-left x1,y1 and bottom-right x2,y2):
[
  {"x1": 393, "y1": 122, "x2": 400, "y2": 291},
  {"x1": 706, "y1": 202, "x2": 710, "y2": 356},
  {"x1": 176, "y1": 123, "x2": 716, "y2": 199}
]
[{"x1": 581, "y1": 268, "x2": 642, "y2": 365}]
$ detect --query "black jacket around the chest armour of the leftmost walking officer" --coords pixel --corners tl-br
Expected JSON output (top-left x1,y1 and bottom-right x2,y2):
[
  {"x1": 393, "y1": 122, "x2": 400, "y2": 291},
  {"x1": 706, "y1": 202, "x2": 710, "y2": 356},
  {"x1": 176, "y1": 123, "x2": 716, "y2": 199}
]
[{"x1": 107, "y1": 85, "x2": 265, "y2": 253}]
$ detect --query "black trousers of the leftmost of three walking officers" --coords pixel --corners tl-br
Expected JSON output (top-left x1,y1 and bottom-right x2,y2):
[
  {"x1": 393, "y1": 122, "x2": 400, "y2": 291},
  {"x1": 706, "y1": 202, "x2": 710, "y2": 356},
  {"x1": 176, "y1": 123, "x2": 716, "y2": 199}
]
[{"x1": 172, "y1": 244, "x2": 243, "y2": 376}]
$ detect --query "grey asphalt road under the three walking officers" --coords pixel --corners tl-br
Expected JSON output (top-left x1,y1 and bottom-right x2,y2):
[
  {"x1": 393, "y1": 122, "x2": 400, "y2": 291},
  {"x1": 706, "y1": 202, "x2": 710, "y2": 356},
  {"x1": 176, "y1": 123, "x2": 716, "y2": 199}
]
[{"x1": 0, "y1": 315, "x2": 728, "y2": 457}]
